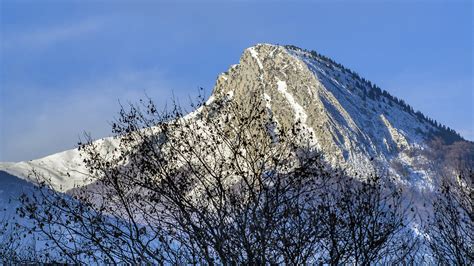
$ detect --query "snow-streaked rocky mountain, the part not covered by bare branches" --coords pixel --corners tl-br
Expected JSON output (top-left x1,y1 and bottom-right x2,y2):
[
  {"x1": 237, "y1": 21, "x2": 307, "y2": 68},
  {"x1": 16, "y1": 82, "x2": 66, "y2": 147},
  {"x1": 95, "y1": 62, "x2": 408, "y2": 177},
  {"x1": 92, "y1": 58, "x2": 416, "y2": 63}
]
[{"x1": 0, "y1": 44, "x2": 474, "y2": 191}]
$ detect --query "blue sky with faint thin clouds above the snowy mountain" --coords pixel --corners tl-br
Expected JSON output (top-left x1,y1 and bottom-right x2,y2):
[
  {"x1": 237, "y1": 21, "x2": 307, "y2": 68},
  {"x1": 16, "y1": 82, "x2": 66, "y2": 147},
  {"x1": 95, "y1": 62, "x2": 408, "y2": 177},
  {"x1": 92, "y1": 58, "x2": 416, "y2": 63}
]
[{"x1": 0, "y1": 0, "x2": 474, "y2": 161}]
